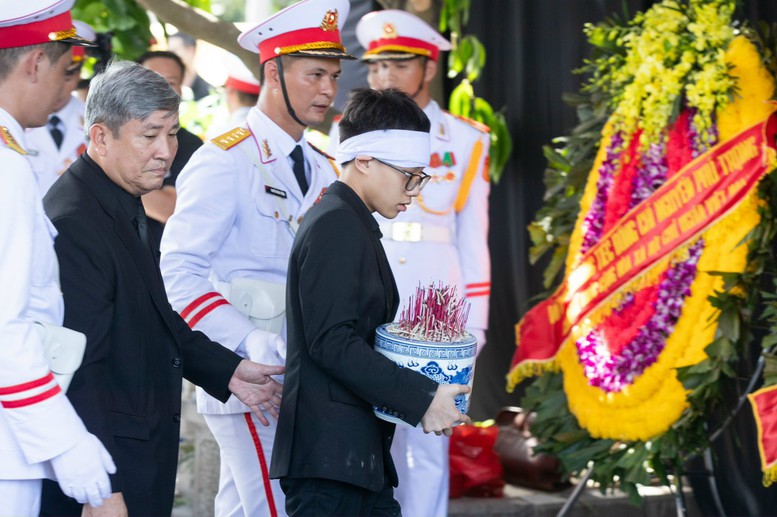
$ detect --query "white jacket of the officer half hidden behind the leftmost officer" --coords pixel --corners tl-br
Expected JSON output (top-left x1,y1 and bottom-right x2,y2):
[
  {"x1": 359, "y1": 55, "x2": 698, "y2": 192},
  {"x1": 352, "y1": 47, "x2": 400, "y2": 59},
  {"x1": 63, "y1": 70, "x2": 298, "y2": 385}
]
[{"x1": 26, "y1": 95, "x2": 86, "y2": 196}]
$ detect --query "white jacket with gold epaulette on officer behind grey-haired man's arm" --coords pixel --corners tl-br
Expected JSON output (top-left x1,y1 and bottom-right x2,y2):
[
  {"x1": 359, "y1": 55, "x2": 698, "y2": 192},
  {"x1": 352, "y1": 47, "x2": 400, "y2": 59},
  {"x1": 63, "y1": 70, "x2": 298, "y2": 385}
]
[{"x1": 161, "y1": 107, "x2": 337, "y2": 414}]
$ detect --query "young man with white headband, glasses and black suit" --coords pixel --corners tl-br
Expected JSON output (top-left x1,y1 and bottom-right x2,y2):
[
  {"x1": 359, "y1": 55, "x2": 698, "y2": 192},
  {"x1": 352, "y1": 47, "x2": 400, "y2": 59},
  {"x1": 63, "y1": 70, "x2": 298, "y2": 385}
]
[{"x1": 270, "y1": 89, "x2": 469, "y2": 516}]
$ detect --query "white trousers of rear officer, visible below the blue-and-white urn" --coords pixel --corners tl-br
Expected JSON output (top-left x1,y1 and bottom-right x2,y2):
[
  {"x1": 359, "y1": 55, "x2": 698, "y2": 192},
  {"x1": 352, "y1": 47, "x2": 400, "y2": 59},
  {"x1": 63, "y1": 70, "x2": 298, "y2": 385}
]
[{"x1": 391, "y1": 425, "x2": 450, "y2": 517}]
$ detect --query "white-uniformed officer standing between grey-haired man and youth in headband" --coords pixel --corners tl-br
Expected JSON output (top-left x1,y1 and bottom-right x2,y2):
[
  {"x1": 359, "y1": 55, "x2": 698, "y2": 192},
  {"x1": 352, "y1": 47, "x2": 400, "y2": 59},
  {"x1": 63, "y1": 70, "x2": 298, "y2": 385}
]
[{"x1": 161, "y1": 0, "x2": 352, "y2": 517}]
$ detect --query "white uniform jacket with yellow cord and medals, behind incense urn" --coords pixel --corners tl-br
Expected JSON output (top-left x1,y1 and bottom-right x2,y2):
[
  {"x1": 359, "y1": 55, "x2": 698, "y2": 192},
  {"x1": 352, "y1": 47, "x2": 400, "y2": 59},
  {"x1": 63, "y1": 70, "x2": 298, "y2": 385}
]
[{"x1": 376, "y1": 101, "x2": 491, "y2": 346}]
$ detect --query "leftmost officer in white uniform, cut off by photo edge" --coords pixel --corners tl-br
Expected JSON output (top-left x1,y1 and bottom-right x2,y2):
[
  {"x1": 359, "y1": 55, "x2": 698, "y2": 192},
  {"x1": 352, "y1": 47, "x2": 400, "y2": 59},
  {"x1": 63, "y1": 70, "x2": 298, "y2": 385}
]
[{"x1": 0, "y1": 0, "x2": 116, "y2": 517}]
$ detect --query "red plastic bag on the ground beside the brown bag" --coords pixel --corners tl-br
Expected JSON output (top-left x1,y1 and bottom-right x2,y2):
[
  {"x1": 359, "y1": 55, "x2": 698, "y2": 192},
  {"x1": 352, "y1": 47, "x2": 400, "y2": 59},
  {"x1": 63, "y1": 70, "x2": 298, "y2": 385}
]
[{"x1": 450, "y1": 425, "x2": 505, "y2": 499}]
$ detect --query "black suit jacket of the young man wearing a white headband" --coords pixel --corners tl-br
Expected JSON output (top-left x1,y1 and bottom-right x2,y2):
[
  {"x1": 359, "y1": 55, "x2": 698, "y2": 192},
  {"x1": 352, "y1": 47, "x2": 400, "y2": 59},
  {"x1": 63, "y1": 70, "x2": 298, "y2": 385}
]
[{"x1": 270, "y1": 182, "x2": 437, "y2": 491}]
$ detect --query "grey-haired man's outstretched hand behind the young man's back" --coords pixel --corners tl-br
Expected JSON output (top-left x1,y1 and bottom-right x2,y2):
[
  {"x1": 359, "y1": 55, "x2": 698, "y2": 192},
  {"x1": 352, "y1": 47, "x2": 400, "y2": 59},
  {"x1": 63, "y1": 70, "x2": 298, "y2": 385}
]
[{"x1": 229, "y1": 359, "x2": 285, "y2": 425}]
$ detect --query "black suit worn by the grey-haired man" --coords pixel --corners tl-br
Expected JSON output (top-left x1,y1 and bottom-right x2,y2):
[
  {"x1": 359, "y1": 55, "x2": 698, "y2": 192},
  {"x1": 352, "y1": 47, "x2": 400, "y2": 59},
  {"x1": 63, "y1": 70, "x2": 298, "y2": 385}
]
[{"x1": 42, "y1": 154, "x2": 240, "y2": 516}]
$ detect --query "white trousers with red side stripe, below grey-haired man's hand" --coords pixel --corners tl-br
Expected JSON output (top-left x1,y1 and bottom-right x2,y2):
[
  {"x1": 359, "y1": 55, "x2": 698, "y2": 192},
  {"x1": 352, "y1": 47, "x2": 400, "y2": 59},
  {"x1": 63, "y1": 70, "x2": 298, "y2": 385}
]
[{"x1": 203, "y1": 413, "x2": 286, "y2": 517}]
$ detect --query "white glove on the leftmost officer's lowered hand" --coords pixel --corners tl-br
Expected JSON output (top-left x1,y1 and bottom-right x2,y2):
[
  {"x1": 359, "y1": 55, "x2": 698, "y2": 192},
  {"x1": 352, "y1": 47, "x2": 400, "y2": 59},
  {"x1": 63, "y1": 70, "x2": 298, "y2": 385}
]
[{"x1": 51, "y1": 434, "x2": 116, "y2": 506}]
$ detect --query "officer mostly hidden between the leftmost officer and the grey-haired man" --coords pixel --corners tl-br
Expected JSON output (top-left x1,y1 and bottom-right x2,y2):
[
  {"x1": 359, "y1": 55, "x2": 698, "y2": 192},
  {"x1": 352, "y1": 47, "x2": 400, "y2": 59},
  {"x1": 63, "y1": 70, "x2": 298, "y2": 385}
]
[{"x1": 26, "y1": 20, "x2": 97, "y2": 196}]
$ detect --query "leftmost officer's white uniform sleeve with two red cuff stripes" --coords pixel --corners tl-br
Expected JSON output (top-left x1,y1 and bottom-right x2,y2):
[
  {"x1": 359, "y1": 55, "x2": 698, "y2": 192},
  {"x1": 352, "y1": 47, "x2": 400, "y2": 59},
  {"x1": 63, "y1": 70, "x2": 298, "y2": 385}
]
[{"x1": 0, "y1": 151, "x2": 86, "y2": 463}]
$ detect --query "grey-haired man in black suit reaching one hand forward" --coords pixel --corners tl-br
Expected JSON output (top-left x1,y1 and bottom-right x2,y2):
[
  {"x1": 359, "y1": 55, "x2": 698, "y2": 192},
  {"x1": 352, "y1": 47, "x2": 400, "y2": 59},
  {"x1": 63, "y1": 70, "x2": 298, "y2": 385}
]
[{"x1": 42, "y1": 61, "x2": 283, "y2": 516}]
